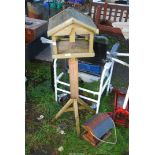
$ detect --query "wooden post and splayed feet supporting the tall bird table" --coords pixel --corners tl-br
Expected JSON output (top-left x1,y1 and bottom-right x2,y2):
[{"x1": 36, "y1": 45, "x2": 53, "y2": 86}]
[{"x1": 53, "y1": 58, "x2": 95, "y2": 135}]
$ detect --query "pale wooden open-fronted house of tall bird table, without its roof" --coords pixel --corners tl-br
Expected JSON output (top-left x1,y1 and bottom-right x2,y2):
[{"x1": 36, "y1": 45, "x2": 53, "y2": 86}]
[{"x1": 52, "y1": 24, "x2": 95, "y2": 59}]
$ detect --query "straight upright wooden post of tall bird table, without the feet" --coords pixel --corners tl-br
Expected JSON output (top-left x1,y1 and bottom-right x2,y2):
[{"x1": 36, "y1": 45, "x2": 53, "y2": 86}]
[{"x1": 68, "y1": 58, "x2": 79, "y2": 99}]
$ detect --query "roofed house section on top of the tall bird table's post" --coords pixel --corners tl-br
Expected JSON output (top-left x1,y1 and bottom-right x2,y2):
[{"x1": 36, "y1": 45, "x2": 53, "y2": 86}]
[{"x1": 48, "y1": 8, "x2": 98, "y2": 59}]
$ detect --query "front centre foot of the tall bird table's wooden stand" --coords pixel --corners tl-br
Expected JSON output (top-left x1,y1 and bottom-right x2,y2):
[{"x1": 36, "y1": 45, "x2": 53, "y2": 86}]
[{"x1": 74, "y1": 99, "x2": 80, "y2": 136}]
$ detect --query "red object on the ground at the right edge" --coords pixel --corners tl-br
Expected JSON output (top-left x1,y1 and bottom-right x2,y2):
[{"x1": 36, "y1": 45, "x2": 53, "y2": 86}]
[{"x1": 113, "y1": 90, "x2": 129, "y2": 128}]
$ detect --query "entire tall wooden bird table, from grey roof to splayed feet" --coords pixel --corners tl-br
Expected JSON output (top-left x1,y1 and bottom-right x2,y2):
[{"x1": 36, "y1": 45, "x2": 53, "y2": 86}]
[{"x1": 47, "y1": 8, "x2": 98, "y2": 135}]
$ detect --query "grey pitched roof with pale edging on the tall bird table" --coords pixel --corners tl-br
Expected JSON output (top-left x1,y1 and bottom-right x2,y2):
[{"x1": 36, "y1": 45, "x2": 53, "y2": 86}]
[{"x1": 48, "y1": 7, "x2": 98, "y2": 33}]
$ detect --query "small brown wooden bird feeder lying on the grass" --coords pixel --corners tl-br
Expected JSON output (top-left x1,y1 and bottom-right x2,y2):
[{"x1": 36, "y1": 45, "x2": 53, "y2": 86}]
[{"x1": 82, "y1": 113, "x2": 114, "y2": 146}]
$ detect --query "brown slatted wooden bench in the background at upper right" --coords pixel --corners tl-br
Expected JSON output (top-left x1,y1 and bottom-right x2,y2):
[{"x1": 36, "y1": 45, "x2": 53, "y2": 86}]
[{"x1": 89, "y1": 2, "x2": 129, "y2": 35}]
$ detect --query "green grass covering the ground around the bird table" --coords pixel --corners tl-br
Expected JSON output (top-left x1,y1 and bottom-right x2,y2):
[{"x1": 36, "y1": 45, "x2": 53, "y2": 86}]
[{"x1": 25, "y1": 62, "x2": 129, "y2": 155}]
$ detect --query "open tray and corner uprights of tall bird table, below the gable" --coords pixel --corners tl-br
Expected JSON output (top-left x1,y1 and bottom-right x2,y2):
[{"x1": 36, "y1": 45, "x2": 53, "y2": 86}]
[{"x1": 52, "y1": 34, "x2": 95, "y2": 59}]
